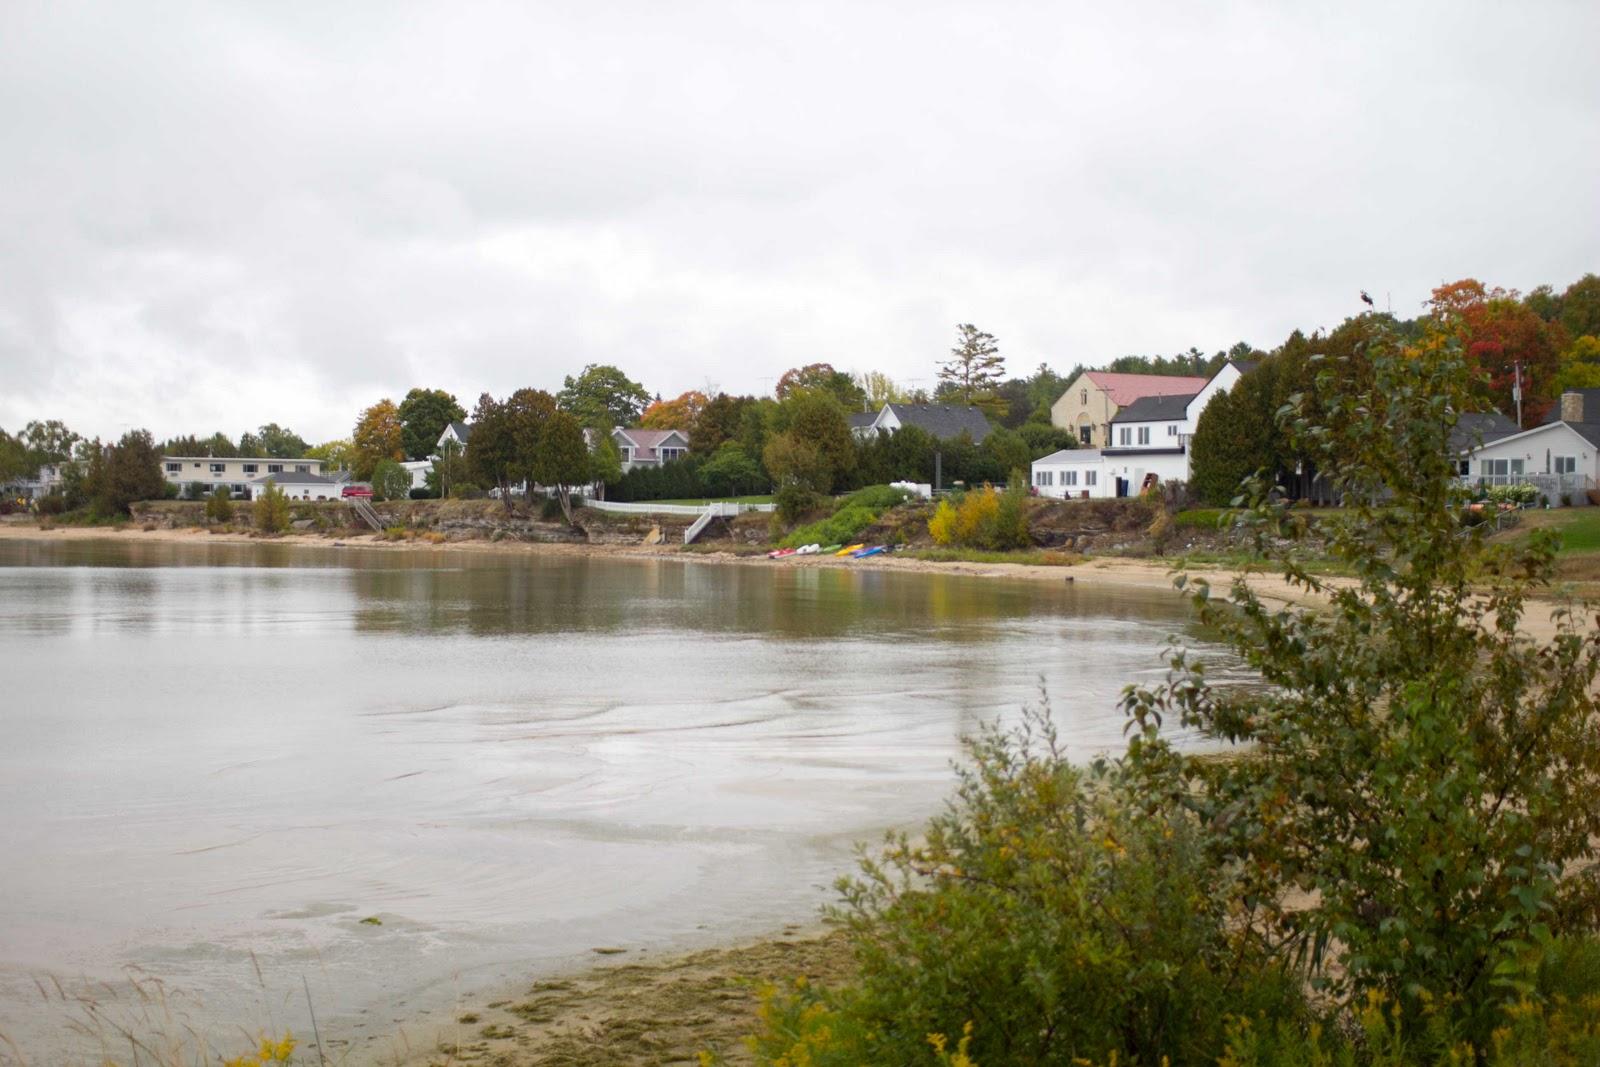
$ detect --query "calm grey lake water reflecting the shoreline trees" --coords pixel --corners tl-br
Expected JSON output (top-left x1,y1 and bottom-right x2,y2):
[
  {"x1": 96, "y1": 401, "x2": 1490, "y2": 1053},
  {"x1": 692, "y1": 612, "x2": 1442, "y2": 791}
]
[{"x1": 0, "y1": 541, "x2": 1186, "y2": 1062}]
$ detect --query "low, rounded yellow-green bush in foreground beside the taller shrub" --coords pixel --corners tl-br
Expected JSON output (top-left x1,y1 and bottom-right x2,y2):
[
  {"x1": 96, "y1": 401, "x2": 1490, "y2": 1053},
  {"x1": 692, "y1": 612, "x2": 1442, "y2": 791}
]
[{"x1": 755, "y1": 713, "x2": 1304, "y2": 1067}]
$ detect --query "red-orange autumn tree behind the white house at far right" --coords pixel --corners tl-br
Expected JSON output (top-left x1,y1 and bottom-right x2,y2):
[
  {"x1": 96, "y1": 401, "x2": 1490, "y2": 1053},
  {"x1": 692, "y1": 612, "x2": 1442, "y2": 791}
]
[{"x1": 1427, "y1": 278, "x2": 1565, "y2": 426}]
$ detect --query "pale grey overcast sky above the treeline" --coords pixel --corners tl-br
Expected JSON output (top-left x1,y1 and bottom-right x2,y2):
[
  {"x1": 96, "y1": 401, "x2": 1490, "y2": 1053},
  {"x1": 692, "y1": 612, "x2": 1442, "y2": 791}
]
[{"x1": 0, "y1": 0, "x2": 1600, "y2": 440}]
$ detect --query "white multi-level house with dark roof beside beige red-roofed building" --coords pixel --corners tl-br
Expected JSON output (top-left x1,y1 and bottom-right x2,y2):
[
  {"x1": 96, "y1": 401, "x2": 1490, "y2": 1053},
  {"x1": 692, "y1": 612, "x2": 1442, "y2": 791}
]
[{"x1": 1032, "y1": 360, "x2": 1254, "y2": 498}]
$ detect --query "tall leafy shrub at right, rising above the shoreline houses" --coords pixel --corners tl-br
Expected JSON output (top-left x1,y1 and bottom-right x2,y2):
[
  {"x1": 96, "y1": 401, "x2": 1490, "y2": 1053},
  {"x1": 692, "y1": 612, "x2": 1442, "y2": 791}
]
[{"x1": 1126, "y1": 323, "x2": 1600, "y2": 1049}]
